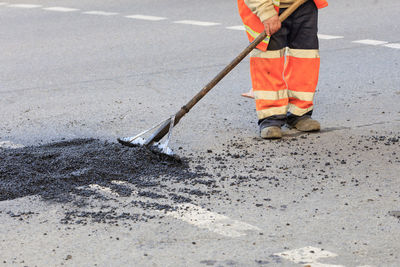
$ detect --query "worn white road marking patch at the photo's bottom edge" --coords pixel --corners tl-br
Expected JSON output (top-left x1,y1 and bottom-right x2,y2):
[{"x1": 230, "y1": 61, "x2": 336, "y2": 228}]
[{"x1": 274, "y1": 247, "x2": 344, "y2": 267}]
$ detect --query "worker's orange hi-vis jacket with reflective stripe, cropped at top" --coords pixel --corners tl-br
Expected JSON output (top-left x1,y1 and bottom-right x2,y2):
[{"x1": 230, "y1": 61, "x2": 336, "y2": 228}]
[{"x1": 238, "y1": 0, "x2": 328, "y2": 51}]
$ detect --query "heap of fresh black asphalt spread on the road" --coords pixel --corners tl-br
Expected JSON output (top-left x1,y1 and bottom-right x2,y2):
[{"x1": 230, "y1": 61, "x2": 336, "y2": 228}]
[{"x1": 0, "y1": 139, "x2": 212, "y2": 224}]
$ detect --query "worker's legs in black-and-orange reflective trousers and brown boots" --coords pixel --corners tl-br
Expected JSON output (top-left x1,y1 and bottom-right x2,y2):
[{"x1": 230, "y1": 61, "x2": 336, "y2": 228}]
[{"x1": 250, "y1": 1, "x2": 320, "y2": 138}]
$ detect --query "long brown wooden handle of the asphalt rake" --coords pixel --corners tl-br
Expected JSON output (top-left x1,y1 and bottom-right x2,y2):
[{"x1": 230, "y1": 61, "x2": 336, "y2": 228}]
[{"x1": 145, "y1": 0, "x2": 308, "y2": 146}]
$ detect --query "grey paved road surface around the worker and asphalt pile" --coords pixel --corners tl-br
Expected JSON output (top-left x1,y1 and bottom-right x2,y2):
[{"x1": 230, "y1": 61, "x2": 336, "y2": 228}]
[{"x1": 0, "y1": 0, "x2": 400, "y2": 266}]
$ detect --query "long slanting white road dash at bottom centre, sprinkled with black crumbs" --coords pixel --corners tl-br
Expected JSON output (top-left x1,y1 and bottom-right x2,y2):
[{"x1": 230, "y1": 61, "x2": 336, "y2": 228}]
[{"x1": 166, "y1": 204, "x2": 260, "y2": 237}]
